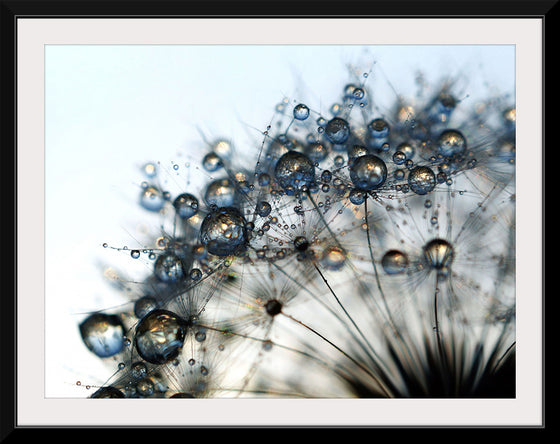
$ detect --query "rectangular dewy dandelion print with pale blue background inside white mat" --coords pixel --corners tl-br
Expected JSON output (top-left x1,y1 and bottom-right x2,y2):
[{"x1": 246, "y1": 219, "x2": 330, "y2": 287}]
[{"x1": 45, "y1": 40, "x2": 516, "y2": 402}]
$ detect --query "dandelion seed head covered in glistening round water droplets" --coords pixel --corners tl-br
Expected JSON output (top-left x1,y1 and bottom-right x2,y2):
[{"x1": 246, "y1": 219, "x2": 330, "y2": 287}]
[{"x1": 79, "y1": 61, "x2": 515, "y2": 398}]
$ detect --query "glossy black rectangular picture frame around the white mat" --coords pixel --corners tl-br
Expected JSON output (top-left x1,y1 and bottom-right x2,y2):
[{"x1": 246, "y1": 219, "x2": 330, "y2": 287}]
[{"x1": 0, "y1": 0, "x2": 558, "y2": 442}]
